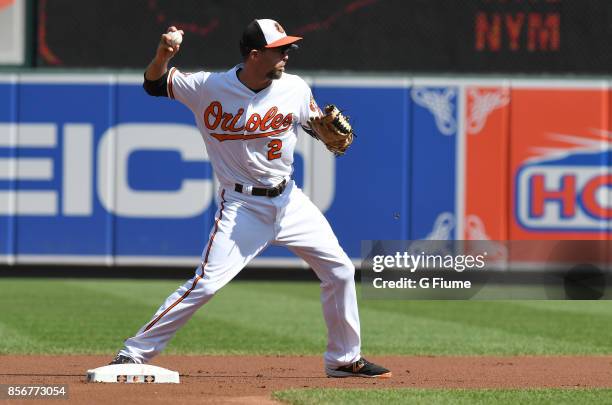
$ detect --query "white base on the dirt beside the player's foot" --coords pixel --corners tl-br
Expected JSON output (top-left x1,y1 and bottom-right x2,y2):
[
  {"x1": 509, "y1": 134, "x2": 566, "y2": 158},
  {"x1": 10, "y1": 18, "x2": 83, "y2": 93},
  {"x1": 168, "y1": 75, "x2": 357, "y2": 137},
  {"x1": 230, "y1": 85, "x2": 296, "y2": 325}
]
[{"x1": 87, "y1": 364, "x2": 179, "y2": 384}]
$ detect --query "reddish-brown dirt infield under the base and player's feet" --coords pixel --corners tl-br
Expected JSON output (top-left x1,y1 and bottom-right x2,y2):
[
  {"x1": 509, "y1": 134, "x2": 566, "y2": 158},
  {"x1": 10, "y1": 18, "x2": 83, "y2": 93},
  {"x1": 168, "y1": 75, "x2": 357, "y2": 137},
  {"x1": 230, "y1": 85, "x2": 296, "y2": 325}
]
[{"x1": 0, "y1": 355, "x2": 612, "y2": 405}]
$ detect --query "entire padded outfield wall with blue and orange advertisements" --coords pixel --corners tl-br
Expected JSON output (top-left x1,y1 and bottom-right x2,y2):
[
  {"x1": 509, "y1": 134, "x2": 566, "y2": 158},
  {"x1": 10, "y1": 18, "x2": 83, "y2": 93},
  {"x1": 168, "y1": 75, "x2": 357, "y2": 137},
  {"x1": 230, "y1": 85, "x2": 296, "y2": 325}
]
[{"x1": 0, "y1": 74, "x2": 612, "y2": 266}]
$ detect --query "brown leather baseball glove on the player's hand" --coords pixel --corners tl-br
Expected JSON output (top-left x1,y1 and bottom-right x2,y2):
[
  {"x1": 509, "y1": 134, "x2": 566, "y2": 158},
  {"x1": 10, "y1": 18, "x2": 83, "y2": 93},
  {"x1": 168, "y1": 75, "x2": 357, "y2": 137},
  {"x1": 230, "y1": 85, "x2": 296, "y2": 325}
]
[{"x1": 308, "y1": 104, "x2": 355, "y2": 156}]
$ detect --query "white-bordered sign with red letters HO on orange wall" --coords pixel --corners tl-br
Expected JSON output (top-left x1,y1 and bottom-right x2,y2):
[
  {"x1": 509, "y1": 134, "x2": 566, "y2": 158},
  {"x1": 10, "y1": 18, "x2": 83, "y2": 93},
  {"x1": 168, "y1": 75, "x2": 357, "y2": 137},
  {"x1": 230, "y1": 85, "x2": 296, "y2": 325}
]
[{"x1": 517, "y1": 165, "x2": 612, "y2": 231}]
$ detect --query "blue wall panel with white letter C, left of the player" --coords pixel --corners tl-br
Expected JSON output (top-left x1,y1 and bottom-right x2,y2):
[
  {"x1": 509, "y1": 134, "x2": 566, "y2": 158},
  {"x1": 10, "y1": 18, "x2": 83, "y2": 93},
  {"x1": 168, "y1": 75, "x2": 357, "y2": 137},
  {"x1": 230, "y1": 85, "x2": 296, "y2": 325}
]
[{"x1": 111, "y1": 83, "x2": 217, "y2": 258}]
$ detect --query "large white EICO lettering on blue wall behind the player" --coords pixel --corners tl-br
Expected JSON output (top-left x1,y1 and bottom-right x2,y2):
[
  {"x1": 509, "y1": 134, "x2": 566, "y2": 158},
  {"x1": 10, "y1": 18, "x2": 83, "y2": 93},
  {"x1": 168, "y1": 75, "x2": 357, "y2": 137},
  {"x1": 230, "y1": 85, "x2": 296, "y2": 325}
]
[{"x1": 0, "y1": 123, "x2": 335, "y2": 218}]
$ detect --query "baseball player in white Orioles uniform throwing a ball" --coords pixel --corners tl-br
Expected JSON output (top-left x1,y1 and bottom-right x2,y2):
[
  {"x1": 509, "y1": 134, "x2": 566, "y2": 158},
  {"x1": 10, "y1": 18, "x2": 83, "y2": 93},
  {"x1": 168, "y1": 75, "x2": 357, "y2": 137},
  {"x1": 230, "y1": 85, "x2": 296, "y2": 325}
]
[{"x1": 111, "y1": 19, "x2": 391, "y2": 377}]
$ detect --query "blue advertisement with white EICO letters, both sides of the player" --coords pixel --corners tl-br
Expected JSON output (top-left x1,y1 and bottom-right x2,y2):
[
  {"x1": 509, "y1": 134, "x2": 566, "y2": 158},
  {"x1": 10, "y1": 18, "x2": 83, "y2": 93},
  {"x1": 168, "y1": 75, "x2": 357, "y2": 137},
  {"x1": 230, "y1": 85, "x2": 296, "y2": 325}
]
[{"x1": 0, "y1": 75, "x2": 411, "y2": 265}]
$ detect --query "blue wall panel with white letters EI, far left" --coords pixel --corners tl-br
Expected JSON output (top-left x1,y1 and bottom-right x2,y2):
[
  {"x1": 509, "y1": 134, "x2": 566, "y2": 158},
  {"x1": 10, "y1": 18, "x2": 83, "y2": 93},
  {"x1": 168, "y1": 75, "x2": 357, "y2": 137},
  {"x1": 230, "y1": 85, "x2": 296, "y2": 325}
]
[{"x1": 16, "y1": 76, "x2": 115, "y2": 256}]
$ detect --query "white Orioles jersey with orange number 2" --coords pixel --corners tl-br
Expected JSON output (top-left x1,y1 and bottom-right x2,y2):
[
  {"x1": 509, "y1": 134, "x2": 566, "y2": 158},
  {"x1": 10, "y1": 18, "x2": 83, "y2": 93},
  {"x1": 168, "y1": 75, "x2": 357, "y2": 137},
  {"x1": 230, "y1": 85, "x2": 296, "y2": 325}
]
[{"x1": 167, "y1": 65, "x2": 320, "y2": 187}]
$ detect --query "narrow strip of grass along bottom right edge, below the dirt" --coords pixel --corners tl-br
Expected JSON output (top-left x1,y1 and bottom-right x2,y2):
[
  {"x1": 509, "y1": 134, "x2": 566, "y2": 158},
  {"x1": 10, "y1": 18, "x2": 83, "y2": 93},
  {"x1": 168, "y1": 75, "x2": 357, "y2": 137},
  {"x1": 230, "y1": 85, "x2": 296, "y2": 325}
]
[{"x1": 273, "y1": 388, "x2": 612, "y2": 405}]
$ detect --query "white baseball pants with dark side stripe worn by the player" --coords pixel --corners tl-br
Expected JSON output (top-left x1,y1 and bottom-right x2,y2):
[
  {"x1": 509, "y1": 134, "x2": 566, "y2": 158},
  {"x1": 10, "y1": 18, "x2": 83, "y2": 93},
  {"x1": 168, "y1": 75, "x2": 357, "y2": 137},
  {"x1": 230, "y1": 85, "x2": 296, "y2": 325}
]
[{"x1": 119, "y1": 180, "x2": 361, "y2": 368}]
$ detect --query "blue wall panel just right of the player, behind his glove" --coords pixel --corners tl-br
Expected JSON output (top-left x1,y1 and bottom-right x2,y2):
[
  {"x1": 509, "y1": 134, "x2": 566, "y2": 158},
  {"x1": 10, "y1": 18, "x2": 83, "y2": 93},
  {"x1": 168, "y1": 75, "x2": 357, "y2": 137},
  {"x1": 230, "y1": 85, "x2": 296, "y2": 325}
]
[{"x1": 314, "y1": 83, "x2": 411, "y2": 257}]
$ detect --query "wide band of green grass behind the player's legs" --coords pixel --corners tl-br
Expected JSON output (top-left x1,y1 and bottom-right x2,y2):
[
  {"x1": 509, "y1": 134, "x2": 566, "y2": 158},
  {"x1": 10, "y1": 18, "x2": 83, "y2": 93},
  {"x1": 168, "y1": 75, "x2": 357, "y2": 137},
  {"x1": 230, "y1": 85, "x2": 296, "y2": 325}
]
[{"x1": 0, "y1": 278, "x2": 612, "y2": 355}]
